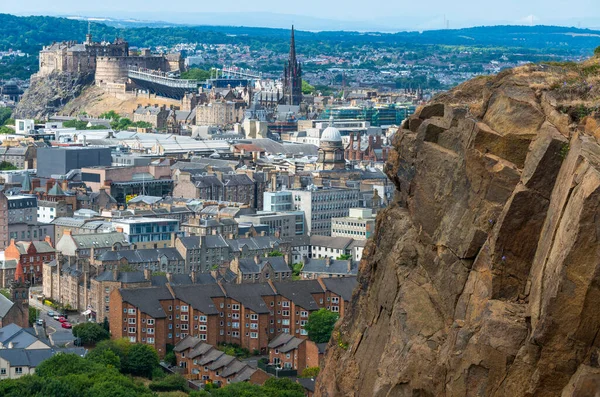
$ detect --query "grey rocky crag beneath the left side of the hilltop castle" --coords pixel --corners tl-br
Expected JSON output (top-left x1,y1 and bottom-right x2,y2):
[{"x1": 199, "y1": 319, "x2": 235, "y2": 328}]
[{"x1": 14, "y1": 71, "x2": 94, "y2": 119}]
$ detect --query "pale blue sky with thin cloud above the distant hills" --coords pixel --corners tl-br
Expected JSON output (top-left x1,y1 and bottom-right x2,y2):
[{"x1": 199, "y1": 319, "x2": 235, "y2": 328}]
[{"x1": 0, "y1": 0, "x2": 600, "y2": 31}]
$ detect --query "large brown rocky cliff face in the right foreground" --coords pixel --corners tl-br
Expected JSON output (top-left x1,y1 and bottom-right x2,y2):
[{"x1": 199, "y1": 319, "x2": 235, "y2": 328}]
[{"x1": 316, "y1": 61, "x2": 600, "y2": 397}]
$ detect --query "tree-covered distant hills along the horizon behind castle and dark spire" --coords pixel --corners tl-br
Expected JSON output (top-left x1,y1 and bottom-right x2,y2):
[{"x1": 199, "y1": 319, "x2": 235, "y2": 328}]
[{"x1": 0, "y1": 14, "x2": 600, "y2": 55}]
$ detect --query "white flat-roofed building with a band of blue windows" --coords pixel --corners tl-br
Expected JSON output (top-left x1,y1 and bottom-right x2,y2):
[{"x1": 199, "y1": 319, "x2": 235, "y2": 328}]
[{"x1": 113, "y1": 218, "x2": 179, "y2": 249}]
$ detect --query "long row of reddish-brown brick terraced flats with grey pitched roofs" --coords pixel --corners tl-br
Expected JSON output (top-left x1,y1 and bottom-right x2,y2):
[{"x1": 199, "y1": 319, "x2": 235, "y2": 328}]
[{"x1": 109, "y1": 277, "x2": 356, "y2": 357}]
